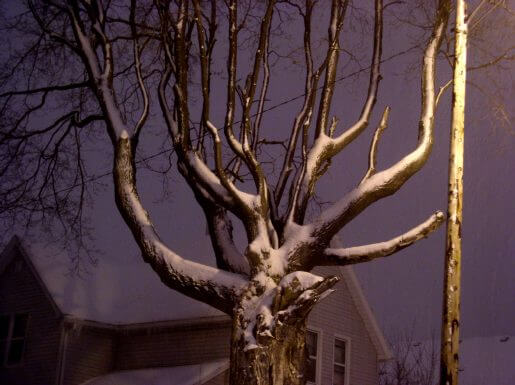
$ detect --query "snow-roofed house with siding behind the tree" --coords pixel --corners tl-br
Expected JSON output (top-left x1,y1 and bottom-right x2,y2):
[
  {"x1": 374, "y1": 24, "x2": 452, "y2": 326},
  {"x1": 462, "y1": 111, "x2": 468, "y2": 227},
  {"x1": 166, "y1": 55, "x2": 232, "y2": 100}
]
[{"x1": 0, "y1": 237, "x2": 391, "y2": 385}]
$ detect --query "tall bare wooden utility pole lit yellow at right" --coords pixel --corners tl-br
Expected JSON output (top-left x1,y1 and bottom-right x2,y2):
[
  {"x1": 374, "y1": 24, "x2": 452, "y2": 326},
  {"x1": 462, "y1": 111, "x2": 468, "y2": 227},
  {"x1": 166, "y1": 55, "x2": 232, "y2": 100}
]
[{"x1": 440, "y1": 0, "x2": 467, "y2": 385}]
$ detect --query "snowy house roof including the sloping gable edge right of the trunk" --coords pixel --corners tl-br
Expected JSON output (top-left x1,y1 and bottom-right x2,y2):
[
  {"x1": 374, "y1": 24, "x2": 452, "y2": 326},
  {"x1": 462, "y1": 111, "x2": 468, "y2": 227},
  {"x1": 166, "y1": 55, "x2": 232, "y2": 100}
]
[{"x1": 0, "y1": 237, "x2": 392, "y2": 360}]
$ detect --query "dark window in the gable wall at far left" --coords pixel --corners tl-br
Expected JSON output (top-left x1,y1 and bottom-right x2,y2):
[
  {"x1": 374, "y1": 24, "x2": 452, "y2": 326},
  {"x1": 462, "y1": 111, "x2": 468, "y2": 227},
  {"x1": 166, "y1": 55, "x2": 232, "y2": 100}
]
[{"x1": 0, "y1": 314, "x2": 29, "y2": 366}]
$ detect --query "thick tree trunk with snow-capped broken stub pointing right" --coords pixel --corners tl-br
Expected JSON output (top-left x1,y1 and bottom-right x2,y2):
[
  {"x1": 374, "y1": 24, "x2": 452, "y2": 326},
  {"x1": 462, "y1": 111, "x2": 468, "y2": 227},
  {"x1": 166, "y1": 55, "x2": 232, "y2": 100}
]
[{"x1": 230, "y1": 272, "x2": 339, "y2": 385}]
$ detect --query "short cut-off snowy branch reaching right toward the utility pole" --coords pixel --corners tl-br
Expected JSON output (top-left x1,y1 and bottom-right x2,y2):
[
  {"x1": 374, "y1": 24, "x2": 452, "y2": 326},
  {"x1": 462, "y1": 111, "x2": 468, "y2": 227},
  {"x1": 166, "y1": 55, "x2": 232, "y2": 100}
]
[{"x1": 321, "y1": 211, "x2": 445, "y2": 265}]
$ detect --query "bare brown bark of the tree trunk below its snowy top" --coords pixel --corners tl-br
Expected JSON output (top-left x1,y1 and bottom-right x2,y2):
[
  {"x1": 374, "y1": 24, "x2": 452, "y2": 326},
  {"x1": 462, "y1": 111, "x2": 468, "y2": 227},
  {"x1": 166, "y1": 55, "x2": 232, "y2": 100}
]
[{"x1": 230, "y1": 319, "x2": 306, "y2": 385}]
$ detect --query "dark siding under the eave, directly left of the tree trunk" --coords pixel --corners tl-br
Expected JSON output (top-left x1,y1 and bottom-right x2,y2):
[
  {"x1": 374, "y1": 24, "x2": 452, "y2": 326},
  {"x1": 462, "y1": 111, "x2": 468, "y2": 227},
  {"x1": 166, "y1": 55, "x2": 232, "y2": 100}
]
[{"x1": 115, "y1": 322, "x2": 231, "y2": 370}]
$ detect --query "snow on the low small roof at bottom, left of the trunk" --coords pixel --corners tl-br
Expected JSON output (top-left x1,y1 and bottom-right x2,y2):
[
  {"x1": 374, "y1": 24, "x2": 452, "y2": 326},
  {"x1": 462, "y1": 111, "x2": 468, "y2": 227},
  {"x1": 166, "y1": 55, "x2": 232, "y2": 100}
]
[{"x1": 82, "y1": 360, "x2": 229, "y2": 385}]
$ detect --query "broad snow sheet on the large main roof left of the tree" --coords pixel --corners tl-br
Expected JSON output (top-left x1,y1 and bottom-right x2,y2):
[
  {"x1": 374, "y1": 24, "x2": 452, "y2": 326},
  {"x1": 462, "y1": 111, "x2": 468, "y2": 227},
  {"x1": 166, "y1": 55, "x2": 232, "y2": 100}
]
[{"x1": 11, "y1": 237, "x2": 223, "y2": 325}]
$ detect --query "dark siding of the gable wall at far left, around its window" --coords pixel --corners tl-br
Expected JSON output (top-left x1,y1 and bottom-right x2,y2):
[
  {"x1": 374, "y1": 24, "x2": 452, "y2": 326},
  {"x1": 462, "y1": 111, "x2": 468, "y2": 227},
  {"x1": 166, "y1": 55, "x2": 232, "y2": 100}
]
[{"x1": 0, "y1": 250, "x2": 60, "y2": 385}]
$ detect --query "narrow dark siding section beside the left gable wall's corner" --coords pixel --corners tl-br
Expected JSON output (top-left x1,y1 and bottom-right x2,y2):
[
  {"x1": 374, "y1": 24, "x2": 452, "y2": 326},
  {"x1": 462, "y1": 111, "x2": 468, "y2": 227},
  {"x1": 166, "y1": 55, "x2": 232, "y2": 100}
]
[{"x1": 62, "y1": 325, "x2": 115, "y2": 385}]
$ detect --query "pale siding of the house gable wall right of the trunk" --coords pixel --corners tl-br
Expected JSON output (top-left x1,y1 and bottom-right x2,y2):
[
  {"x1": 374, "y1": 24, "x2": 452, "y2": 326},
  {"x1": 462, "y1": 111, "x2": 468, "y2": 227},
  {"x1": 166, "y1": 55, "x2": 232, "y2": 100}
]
[{"x1": 308, "y1": 267, "x2": 379, "y2": 385}]
